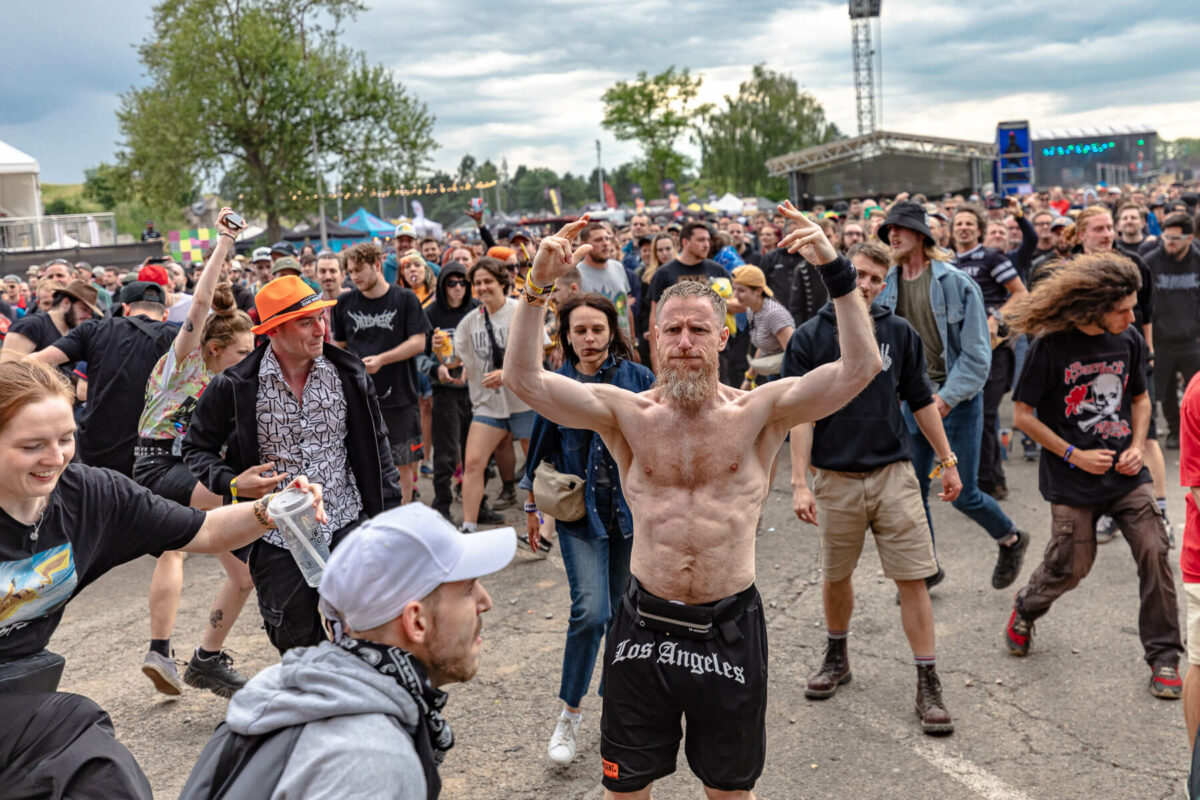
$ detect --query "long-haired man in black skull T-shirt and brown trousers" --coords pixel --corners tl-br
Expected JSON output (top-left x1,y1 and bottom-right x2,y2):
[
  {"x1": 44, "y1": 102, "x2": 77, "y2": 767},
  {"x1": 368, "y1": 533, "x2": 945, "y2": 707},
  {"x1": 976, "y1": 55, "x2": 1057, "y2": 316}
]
[{"x1": 1004, "y1": 251, "x2": 1183, "y2": 699}]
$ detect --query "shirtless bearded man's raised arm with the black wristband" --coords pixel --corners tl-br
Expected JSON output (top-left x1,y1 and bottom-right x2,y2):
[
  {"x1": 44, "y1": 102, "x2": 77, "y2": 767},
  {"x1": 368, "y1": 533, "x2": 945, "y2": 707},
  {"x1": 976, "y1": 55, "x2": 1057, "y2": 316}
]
[{"x1": 754, "y1": 200, "x2": 883, "y2": 428}]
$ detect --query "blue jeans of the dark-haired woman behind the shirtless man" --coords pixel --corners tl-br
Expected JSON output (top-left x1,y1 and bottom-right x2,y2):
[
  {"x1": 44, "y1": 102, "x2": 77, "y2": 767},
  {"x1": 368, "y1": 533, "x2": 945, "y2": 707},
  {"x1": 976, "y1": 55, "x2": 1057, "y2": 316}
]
[{"x1": 558, "y1": 531, "x2": 634, "y2": 709}]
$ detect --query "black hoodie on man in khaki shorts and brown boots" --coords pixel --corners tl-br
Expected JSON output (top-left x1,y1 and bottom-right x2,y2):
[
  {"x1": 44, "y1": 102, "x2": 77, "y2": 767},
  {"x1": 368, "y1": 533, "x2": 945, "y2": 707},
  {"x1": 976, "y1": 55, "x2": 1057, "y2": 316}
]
[{"x1": 782, "y1": 302, "x2": 934, "y2": 473}]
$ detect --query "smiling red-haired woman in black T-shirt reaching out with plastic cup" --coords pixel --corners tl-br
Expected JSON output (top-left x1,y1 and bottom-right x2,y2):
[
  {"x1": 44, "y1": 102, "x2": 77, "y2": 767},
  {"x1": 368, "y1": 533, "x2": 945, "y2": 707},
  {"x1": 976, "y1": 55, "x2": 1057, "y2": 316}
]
[{"x1": 0, "y1": 360, "x2": 325, "y2": 799}]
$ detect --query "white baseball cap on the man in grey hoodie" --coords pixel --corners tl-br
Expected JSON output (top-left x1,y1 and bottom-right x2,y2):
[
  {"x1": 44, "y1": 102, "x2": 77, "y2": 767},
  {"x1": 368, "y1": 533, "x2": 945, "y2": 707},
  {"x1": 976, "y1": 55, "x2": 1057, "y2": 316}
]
[{"x1": 318, "y1": 503, "x2": 517, "y2": 631}]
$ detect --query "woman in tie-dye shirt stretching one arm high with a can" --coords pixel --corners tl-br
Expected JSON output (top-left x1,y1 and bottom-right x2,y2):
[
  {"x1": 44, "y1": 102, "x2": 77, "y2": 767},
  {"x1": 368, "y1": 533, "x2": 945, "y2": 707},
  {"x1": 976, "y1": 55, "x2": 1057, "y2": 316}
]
[{"x1": 133, "y1": 209, "x2": 254, "y2": 697}]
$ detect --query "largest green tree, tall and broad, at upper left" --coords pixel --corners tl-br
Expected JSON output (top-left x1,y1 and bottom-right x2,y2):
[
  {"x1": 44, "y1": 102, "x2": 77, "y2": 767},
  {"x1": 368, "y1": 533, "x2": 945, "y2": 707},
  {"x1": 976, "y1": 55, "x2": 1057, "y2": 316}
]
[{"x1": 118, "y1": 0, "x2": 436, "y2": 237}]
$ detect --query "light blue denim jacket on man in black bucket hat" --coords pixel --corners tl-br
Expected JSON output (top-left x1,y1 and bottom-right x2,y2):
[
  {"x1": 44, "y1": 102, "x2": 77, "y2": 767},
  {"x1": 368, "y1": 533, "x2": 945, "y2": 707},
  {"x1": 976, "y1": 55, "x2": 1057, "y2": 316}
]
[{"x1": 875, "y1": 261, "x2": 991, "y2": 408}]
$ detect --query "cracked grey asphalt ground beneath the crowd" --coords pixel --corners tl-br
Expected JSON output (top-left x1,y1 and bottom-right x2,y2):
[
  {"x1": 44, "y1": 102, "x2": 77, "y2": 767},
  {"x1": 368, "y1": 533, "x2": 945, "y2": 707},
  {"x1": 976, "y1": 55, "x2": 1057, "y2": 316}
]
[{"x1": 52, "y1": 407, "x2": 1189, "y2": 800}]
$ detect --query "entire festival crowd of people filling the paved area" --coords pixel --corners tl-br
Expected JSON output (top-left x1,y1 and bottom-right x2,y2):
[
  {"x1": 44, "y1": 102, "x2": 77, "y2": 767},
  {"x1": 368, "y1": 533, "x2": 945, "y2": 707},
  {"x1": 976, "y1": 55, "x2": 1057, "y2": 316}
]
[{"x1": 0, "y1": 176, "x2": 1200, "y2": 798}]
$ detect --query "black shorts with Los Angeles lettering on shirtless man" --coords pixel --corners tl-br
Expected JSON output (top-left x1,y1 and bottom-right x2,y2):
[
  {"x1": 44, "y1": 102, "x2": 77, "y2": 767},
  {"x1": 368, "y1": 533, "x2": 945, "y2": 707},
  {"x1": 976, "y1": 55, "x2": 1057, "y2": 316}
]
[{"x1": 600, "y1": 578, "x2": 767, "y2": 792}]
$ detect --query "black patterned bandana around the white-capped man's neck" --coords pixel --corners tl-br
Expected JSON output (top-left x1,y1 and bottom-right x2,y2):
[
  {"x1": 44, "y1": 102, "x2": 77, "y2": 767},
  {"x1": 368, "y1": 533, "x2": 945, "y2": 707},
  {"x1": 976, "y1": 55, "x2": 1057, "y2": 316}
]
[{"x1": 337, "y1": 636, "x2": 454, "y2": 800}]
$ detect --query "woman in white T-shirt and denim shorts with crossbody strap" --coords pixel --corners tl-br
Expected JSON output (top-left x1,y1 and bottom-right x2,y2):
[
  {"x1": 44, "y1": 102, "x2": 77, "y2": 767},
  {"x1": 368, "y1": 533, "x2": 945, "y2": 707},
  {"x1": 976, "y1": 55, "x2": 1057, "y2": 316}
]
[{"x1": 442, "y1": 255, "x2": 550, "y2": 531}]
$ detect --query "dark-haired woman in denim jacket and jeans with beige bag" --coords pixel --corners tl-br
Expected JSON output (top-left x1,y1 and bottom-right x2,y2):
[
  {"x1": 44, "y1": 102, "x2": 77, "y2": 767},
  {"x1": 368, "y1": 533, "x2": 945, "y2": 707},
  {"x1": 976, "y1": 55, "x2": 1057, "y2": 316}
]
[{"x1": 521, "y1": 293, "x2": 654, "y2": 764}]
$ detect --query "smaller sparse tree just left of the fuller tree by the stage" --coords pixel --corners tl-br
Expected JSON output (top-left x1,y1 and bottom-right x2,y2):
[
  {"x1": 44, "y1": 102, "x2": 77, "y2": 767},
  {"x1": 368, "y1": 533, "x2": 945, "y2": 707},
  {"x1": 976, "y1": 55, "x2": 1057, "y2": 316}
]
[{"x1": 600, "y1": 66, "x2": 712, "y2": 185}]
